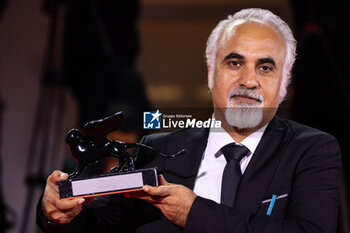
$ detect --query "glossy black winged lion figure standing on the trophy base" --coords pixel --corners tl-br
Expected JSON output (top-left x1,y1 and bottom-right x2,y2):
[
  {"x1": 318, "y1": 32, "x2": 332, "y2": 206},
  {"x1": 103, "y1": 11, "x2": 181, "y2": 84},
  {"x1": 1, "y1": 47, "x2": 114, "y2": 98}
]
[{"x1": 65, "y1": 112, "x2": 186, "y2": 178}]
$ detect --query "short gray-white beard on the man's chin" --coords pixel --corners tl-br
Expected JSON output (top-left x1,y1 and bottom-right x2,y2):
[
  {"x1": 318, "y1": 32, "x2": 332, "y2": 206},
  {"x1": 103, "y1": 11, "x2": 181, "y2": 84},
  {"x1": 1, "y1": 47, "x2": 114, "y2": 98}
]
[{"x1": 225, "y1": 103, "x2": 263, "y2": 129}]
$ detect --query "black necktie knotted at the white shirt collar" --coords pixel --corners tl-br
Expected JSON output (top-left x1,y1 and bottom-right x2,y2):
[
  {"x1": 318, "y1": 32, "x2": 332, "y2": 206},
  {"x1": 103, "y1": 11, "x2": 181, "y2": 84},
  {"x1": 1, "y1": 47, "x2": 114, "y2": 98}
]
[{"x1": 221, "y1": 143, "x2": 250, "y2": 207}]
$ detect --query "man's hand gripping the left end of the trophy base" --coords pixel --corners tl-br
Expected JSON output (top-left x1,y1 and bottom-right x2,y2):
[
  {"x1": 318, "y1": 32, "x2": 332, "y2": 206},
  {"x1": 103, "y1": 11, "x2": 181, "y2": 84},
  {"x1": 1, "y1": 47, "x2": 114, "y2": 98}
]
[{"x1": 42, "y1": 171, "x2": 87, "y2": 224}]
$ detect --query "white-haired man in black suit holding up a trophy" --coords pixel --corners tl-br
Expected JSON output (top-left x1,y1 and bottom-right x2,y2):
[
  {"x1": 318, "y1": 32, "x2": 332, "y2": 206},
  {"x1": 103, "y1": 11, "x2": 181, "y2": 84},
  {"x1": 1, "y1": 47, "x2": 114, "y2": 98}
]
[{"x1": 38, "y1": 8, "x2": 341, "y2": 233}]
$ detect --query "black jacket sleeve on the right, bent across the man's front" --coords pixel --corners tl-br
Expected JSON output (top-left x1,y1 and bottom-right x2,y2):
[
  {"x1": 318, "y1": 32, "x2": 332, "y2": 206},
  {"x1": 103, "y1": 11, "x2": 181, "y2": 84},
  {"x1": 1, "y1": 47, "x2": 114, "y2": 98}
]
[{"x1": 185, "y1": 134, "x2": 341, "y2": 233}]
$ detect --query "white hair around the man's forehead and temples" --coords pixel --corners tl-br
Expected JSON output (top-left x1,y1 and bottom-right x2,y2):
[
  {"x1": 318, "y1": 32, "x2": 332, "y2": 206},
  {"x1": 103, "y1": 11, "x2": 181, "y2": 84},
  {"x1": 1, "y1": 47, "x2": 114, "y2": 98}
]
[{"x1": 205, "y1": 8, "x2": 296, "y2": 100}]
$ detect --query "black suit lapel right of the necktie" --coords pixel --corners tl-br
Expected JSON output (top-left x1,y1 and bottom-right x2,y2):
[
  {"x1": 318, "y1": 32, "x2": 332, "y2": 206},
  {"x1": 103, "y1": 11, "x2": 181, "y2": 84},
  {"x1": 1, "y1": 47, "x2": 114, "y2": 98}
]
[{"x1": 235, "y1": 117, "x2": 292, "y2": 213}]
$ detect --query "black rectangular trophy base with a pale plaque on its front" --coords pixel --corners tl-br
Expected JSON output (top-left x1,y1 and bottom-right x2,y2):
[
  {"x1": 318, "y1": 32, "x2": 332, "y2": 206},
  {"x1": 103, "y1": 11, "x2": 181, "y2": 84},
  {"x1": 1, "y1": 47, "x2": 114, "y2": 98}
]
[{"x1": 58, "y1": 168, "x2": 158, "y2": 199}]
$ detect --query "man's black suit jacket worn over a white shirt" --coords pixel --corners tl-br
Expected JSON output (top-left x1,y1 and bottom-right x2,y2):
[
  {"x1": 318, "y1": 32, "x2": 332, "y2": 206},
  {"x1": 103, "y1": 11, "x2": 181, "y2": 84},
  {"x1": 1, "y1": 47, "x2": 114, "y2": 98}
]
[{"x1": 38, "y1": 117, "x2": 341, "y2": 233}]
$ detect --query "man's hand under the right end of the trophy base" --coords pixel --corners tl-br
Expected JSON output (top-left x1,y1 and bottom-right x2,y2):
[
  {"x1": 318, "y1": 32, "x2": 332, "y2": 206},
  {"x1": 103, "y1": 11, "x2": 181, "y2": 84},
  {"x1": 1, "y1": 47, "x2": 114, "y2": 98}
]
[{"x1": 125, "y1": 175, "x2": 197, "y2": 227}]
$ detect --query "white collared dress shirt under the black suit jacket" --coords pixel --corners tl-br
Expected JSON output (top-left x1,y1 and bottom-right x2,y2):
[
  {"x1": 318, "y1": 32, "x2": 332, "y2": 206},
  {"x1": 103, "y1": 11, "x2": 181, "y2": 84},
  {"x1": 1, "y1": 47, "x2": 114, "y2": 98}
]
[{"x1": 193, "y1": 120, "x2": 267, "y2": 203}]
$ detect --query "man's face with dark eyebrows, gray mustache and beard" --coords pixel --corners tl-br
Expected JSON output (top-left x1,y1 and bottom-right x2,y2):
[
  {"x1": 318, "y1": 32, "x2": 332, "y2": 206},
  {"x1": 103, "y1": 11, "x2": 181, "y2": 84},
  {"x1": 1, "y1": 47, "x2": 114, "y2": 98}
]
[{"x1": 209, "y1": 22, "x2": 286, "y2": 128}]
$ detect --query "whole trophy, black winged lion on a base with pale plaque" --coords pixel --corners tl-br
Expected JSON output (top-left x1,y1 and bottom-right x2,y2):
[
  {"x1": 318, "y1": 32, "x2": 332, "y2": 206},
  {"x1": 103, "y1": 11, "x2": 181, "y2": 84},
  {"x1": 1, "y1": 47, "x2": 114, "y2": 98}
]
[{"x1": 58, "y1": 112, "x2": 186, "y2": 199}]
